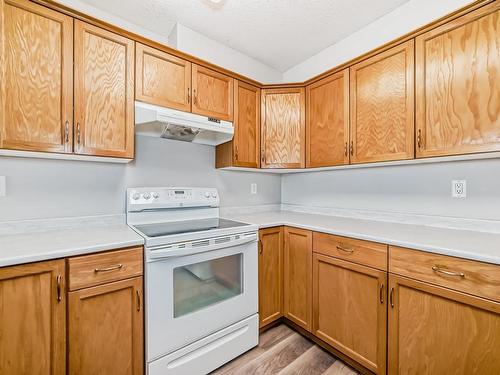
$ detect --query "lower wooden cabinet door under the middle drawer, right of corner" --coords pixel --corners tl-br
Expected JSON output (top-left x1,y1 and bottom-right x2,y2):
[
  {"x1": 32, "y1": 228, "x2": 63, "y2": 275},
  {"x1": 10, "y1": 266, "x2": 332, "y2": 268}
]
[{"x1": 313, "y1": 253, "x2": 387, "y2": 374}]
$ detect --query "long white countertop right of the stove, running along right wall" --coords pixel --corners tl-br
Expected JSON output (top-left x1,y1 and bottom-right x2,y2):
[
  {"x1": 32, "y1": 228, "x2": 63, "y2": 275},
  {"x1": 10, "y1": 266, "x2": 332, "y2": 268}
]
[{"x1": 226, "y1": 211, "x2": 500, "y2": 265}]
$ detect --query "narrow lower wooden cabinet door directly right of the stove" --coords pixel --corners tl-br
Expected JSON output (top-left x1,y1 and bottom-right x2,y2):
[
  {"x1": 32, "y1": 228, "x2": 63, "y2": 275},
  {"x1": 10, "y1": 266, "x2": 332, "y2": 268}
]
[{"x1": 259, "y1": 227, "x2": 283, "y2": 327}]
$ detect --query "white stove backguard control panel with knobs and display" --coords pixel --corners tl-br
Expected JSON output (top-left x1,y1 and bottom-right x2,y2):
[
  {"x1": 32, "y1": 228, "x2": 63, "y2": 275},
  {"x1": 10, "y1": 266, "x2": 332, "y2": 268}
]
[{"x1": 127, "y1": 187, "x2": 219, "y2": 211}]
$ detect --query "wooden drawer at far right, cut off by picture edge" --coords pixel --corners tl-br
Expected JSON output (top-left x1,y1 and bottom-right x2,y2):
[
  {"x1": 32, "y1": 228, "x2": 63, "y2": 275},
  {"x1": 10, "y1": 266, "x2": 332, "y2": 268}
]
[{"x1": 389, "y1": 246, "x2": 500, "y2": 301}]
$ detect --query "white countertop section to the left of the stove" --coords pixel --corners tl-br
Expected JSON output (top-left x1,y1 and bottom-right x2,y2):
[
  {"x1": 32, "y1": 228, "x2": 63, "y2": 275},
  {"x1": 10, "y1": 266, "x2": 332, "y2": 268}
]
[{"x1": 0, "y1": 223, "x2": 144, "y2": 267}]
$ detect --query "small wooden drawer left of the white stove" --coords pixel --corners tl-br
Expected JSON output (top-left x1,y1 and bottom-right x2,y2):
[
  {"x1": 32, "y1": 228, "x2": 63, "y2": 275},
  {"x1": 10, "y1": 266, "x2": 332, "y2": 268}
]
[{"x1": 68, "y1": 247, "x2": 142, "y2": 290}]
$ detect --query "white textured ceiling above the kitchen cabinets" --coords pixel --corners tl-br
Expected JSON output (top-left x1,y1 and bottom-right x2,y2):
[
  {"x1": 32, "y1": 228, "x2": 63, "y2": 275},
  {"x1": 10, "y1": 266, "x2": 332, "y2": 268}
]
[{"x1": 76, "y1": 0, "x2": 408, "y2": 72}]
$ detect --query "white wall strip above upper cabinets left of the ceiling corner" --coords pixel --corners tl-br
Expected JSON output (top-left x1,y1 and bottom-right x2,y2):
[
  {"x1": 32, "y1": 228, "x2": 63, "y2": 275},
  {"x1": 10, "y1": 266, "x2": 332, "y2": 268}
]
[{"x1": 169, "y1": 23, "x2": 283, "y2": 83}]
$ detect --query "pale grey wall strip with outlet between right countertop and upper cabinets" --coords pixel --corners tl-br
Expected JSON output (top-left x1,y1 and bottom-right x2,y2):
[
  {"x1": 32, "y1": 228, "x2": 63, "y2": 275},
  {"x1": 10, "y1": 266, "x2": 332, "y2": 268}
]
[{"x1": 281, "y1": 159, "x2": 500, "y2": 220}]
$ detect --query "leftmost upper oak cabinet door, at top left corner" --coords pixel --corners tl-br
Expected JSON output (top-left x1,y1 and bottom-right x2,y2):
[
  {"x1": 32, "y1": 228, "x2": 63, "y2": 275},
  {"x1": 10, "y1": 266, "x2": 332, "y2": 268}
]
[{"x1": 0, "y1": 0, "x2": 73, "y2": 153}]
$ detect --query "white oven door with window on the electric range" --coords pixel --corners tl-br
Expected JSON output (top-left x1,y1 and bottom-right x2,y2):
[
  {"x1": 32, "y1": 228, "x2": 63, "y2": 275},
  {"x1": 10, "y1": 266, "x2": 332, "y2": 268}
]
[{"x1": 146, "y1": 234, "x2": 258, "y2": 362}]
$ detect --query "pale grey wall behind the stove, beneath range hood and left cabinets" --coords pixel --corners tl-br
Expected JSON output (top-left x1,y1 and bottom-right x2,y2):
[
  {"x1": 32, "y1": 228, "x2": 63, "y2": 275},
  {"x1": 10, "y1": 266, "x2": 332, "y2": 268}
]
[{"x1": 0, "y1": 137, "x2": 281, "y2": 221}]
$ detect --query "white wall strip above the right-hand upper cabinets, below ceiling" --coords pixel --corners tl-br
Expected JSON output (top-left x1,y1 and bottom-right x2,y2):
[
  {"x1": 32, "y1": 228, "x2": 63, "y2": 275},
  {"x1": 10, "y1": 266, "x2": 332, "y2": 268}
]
[{"x1": 283, "y1": 0, "x2": 471, "y2": 82}]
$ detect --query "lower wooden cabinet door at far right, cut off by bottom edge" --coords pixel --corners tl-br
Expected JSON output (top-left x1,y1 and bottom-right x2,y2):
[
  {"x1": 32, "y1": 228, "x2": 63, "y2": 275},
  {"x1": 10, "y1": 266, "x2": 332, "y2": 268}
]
[{"x1": 388, "y1": 274, "x2": 500, "y2": 375}]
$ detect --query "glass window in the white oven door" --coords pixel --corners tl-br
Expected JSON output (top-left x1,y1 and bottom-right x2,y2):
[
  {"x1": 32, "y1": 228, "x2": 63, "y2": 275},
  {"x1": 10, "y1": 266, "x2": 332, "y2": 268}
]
[{"x1": 174, "y1": 254, "x2": 243, "y2": 318}]
